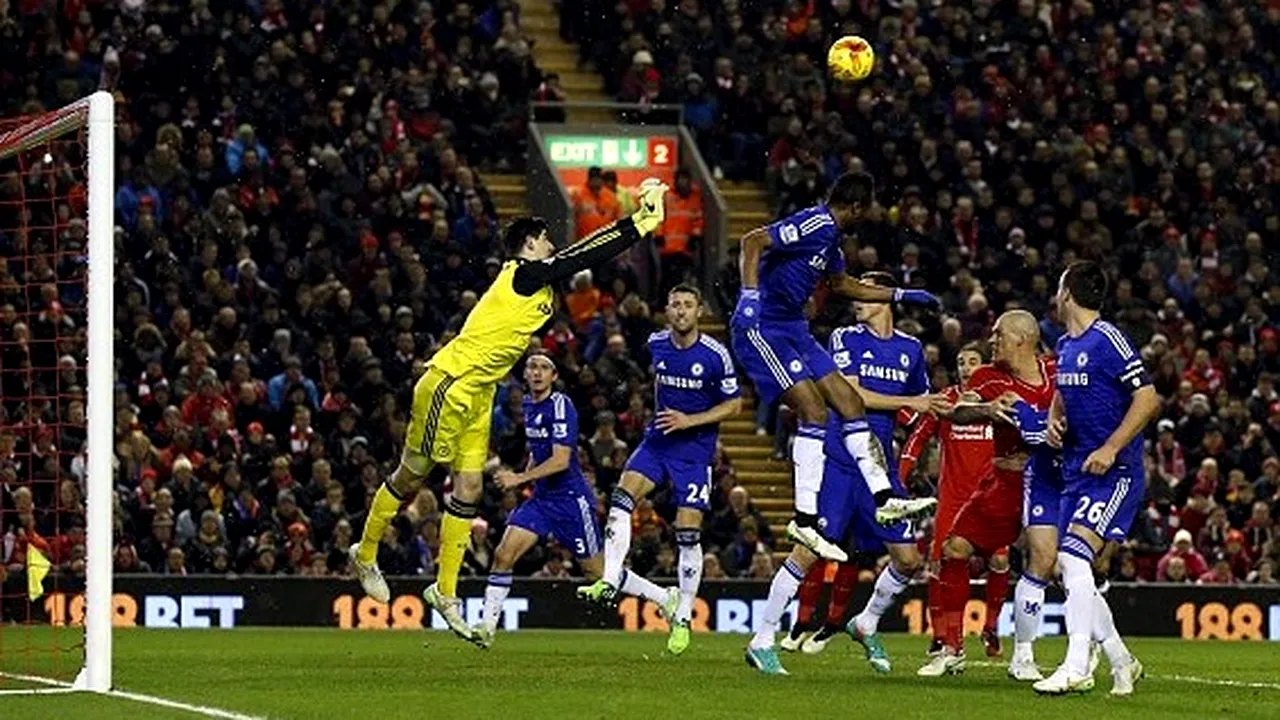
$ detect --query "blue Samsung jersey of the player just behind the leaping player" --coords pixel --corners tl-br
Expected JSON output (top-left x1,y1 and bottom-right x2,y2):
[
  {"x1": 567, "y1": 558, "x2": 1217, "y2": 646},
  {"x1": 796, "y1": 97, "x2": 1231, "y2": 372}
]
[{"x1": 828, "y1": 325, "x2": 929, "y2": 453}]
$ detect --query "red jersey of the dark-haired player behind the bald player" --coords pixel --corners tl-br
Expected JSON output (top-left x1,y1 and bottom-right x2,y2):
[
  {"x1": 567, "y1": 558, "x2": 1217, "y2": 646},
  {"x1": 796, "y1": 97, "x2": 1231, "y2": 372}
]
[{"x1": 899, "y1": 386, "x2": 995, "y2": 502}]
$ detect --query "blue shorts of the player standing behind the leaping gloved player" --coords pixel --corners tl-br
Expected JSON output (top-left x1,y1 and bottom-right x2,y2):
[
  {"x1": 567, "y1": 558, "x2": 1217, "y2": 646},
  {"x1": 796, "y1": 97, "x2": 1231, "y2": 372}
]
[{"x1": 818, "y1": 457, "x2": 915, "y2": 552}]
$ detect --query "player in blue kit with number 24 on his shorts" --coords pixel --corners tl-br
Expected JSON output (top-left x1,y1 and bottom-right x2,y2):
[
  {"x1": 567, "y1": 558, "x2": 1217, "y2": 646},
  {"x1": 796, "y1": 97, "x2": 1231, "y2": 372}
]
[{"x1": 579, "y1": 284, "x2": 742, "y2": 655}]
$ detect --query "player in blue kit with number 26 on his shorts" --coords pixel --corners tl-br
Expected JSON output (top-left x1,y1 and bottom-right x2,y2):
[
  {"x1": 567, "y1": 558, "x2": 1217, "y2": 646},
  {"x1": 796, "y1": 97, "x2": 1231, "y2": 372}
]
[{"x1": 1033, "y1": 261, "x2": 1160, "y2": 696}]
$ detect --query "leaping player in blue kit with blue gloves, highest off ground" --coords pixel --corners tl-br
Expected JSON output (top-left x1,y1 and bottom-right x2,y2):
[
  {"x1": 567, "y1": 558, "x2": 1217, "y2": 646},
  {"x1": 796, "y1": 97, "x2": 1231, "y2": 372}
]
[{"x1": 730, "y1": 173, "x2": 938, "y2": 562}]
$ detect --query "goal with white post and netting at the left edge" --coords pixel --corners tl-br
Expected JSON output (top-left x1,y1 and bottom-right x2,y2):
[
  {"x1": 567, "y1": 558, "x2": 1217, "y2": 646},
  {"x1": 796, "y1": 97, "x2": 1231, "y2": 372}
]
[{"x1": 0, "y1": 92, "x2": 115, "y2": 693}]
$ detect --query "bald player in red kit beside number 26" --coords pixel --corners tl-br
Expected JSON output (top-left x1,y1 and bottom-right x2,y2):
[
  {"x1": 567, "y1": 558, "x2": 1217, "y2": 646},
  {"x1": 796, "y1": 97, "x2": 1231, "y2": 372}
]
[{"x1": 916, "y1": 310, "x2": 1056, "y2": 676}]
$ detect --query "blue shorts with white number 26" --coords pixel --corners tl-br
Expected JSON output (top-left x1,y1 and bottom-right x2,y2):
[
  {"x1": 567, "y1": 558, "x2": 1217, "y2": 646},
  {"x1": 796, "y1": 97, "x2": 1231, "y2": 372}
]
[{"x1": 1062, "y1": 462, "x2": 1147, "y2": 542}]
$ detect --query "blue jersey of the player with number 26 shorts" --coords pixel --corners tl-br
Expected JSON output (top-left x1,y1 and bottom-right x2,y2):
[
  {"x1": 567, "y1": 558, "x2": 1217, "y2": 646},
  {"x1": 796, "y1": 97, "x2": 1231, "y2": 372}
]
[{"x1": 1057, "y1": 320, "x2": 1151, "y2": 478}]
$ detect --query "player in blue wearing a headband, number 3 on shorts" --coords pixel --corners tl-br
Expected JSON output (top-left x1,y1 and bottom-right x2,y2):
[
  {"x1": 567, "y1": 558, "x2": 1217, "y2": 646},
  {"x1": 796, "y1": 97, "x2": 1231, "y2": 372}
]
[{"x1": 472, "y1": 351, "x2": 676, "y2": 647}]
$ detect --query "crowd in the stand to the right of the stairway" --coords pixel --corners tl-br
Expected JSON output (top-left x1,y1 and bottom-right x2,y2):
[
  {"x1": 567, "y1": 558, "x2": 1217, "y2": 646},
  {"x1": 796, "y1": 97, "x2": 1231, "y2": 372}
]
[{"x1": 581, "y1": 0, "x2": 1280, "y2": 582}]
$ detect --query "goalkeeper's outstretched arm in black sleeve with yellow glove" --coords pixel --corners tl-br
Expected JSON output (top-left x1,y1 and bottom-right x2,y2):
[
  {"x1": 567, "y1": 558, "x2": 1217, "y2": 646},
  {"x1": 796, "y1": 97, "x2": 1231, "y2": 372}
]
[{"x1": 513, "y1": 178, "x2": 667, "y2": 295}]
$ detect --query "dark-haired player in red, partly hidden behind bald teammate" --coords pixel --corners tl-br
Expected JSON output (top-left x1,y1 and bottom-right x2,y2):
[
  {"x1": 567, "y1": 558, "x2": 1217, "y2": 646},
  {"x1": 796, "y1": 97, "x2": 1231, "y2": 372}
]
[{"x1": 899, "y1": 342, "x2": 1009, "y2": 657}]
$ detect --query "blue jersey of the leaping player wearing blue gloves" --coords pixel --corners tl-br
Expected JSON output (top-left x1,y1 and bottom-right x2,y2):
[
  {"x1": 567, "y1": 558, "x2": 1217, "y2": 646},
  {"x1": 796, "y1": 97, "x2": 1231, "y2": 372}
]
[{"x1": 759, "y1": 205, "x2": 845, "y2": 322}]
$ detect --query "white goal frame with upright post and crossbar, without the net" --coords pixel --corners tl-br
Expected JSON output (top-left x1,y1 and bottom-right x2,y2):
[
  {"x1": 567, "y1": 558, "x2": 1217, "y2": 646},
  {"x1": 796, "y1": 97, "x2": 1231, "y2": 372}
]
[{"x1": 0, "y1": 91, "x2": 115, "y2": 693}]
